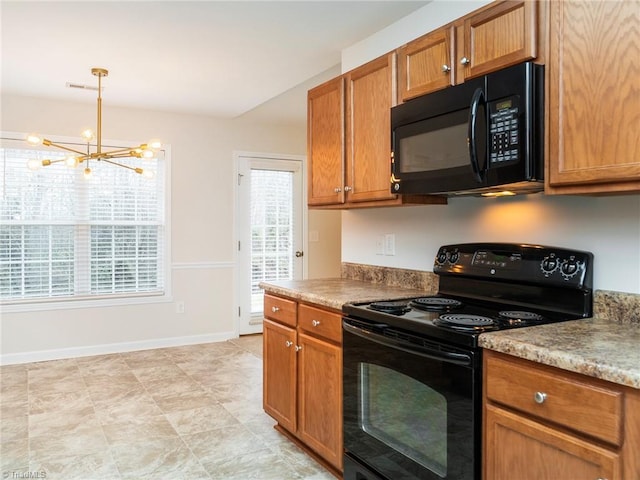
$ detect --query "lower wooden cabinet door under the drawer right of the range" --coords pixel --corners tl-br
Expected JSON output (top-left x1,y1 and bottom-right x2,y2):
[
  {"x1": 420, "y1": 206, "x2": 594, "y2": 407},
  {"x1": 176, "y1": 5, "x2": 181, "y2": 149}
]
[{"x1": 483, "y1": 405, "x2": 622, "y2": 480}]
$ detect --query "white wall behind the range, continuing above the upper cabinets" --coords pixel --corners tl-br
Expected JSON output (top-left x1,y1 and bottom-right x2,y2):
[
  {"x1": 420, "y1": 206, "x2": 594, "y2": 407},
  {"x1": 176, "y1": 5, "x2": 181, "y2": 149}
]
[{"x1": 342, "y1": 1, "x2": 640, "y2": 293}]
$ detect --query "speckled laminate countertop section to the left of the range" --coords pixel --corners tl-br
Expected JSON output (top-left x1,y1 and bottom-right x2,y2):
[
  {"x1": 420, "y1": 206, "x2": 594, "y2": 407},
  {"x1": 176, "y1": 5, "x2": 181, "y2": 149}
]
[{"x1": 260, "y1": 278, "x2": 425, "y2": 310}]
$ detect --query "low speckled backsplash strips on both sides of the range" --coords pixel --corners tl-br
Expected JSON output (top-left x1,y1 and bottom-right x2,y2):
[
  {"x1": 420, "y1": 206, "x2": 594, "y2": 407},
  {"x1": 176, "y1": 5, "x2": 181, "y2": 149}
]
[{"x1": 341, "y1": 262, "x2": 640, "y2": 324}]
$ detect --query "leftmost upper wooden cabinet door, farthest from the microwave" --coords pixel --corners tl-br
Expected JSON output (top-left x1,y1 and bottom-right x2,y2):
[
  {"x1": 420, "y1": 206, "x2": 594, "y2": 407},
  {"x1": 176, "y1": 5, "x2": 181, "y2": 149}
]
[{"x1": 307, "y1": 77, "x2": 345, "y2": 205}]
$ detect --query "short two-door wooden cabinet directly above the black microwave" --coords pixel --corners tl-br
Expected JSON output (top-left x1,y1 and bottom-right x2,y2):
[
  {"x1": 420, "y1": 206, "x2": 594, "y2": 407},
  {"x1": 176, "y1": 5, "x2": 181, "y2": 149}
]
[{"x1": 398, "y1": 1, "x2": 540, "y2": 101}]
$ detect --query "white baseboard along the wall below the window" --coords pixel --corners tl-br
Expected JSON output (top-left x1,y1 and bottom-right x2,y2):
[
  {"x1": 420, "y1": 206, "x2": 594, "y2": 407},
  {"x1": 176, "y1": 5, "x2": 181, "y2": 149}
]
[{"x1": 0, "y1": 332, "x2": 238, "y2": 365}]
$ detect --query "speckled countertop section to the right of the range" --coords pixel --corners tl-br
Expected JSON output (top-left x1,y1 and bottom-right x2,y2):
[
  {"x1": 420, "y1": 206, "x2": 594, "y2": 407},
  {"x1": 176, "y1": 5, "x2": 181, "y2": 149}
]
[{"x1": 479, "y1": 317, "x2": 640, "y2": 389}]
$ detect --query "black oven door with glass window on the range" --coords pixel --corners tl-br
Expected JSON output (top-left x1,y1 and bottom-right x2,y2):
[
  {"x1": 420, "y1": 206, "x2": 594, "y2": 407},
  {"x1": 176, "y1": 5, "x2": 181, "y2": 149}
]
[{"x1": 343, "y1": 318, "x2": 481, "y2": 480}]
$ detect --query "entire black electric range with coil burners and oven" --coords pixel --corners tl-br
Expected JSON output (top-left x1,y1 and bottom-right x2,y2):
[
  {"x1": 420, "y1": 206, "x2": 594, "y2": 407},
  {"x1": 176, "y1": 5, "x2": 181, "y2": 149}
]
[{"x1": 342, "y1": 243, "x2": 593, "y2": 480}]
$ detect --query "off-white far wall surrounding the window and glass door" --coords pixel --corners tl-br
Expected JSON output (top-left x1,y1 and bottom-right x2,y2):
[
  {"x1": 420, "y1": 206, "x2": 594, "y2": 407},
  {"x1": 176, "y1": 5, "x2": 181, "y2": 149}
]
[{"x1": 0, "y1": 88, "x2": 340, "y2": 363}]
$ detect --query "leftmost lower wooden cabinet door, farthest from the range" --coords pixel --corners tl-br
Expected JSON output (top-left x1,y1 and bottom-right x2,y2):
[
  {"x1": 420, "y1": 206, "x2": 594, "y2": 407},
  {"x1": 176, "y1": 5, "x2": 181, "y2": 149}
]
[{"x1": 262, "y1": 319, "x2": 296, "y2": 432}]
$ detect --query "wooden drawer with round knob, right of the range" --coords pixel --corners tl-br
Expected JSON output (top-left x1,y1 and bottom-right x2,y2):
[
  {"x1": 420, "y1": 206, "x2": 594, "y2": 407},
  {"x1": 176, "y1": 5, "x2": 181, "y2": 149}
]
[{"x1": 485, "y1": 352, "x2": 623, "y2": 445}]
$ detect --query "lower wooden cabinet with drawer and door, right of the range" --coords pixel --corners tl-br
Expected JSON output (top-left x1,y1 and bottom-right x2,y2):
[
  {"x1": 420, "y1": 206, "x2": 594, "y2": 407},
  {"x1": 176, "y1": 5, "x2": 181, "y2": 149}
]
[{"x1": 483, "y1": 351, "x2": 640, "y2": 480}]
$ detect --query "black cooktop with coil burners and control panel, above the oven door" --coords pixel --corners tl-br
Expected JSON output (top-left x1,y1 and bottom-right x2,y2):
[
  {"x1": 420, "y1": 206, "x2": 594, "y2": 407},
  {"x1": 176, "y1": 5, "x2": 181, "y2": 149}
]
[{"x1": 343, "y1": 243, "x2": 593, "y2": 347}]
